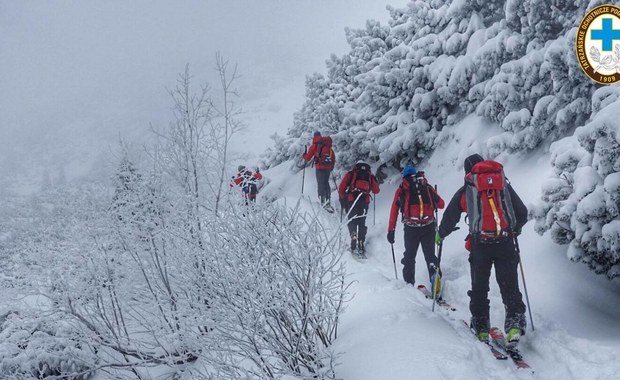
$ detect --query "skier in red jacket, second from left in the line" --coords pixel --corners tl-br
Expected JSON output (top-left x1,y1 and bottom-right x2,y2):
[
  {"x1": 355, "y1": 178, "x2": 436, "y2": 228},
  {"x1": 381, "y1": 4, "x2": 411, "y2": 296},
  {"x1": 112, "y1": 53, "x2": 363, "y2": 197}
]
[{"x1": 303, "y1": 131, "x2": 336, "y2": 212}]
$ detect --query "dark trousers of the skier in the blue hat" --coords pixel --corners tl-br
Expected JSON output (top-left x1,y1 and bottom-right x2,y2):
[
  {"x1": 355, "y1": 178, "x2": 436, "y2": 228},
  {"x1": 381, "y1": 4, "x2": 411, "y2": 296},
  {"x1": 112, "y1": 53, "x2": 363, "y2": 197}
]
[{"x1": 400, "y1": 223, "x2": 437, "y2": 284}]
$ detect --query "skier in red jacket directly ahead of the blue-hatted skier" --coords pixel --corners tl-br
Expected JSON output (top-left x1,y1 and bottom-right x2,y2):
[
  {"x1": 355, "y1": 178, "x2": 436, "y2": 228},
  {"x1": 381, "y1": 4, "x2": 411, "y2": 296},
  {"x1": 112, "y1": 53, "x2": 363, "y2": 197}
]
[{"x1": 338, "y1": 161, "x2": 379, "y2": 257}]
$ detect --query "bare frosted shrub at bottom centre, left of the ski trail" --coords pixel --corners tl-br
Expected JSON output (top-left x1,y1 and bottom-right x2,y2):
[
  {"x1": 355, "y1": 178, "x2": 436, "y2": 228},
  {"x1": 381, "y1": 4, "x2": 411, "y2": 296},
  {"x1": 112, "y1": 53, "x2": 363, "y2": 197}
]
[{"x1": 199, "y1": 203, "x2": 347, "y2": 379}]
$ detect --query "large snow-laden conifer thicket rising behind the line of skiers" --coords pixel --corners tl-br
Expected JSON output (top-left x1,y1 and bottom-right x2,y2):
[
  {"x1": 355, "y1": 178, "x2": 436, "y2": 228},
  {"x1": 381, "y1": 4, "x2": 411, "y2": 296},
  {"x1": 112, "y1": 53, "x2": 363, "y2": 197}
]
[{"x1": 266, "y1": 0, "x2": 600, "y2": 168}]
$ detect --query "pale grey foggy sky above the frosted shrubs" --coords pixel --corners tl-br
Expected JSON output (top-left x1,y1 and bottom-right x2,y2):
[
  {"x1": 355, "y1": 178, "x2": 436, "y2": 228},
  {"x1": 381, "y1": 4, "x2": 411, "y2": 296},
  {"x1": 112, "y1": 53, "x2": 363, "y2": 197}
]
[{"x1": 0, "y1": 0, "x2": 398, "y2": 184}]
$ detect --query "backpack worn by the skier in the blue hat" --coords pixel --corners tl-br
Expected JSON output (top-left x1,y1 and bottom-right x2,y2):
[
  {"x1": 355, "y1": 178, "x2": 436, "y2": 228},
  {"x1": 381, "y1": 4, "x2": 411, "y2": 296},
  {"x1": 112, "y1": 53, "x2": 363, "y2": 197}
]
[{"x1": 399, "y1": 172, "x2": 436, "y2": 227}]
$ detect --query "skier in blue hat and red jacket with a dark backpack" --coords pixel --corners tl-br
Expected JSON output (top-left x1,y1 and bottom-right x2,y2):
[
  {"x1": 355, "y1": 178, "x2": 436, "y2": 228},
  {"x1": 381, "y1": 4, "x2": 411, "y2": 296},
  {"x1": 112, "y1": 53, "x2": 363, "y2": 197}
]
[{"x1": 387, "y1": 165, "x2": 445, "y2": 294}]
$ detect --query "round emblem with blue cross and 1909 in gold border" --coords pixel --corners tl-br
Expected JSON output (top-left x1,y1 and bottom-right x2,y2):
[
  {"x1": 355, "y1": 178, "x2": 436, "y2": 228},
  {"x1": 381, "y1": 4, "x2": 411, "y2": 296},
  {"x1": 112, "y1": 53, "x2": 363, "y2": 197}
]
[{"x1": 575, "y1": 4, "x2": 620, "y2": 84}]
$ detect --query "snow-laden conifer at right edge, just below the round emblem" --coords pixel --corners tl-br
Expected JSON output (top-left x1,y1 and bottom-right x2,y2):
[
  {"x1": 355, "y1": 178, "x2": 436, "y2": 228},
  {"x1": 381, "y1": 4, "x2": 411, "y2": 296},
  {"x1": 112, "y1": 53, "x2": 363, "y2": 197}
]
[{"x1": 534, "y1": 87, "x2": 620, "y2": 279}]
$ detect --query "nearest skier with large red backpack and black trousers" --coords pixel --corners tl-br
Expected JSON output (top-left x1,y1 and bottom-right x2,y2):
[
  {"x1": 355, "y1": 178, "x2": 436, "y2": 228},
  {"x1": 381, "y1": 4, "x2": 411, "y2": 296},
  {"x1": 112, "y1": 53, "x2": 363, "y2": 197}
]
[{"x1": 435, "y1": 154, "x2": 527, "y2": 348}]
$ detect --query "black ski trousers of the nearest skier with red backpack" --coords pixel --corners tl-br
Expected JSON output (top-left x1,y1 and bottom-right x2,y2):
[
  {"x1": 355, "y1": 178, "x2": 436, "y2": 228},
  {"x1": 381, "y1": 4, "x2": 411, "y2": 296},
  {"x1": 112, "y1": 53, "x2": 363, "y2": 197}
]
[{"x1": 468, "y1": 239, "x2": 527, "y2": 332}]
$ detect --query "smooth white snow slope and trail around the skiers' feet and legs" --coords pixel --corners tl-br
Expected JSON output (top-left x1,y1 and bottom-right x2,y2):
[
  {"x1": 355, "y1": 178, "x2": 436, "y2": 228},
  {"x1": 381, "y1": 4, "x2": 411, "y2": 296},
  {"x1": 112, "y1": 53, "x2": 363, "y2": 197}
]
[{"x1": 261, "y1": 117, "x2": 620, "y2": 380}]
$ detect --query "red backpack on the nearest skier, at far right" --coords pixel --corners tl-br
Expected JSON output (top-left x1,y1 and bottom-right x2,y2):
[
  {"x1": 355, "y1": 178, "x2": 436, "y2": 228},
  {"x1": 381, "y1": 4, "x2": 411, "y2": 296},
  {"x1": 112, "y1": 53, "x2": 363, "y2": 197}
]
[{"x1": 465, "y1": 160, "x2": 516, "y2": 240}]
